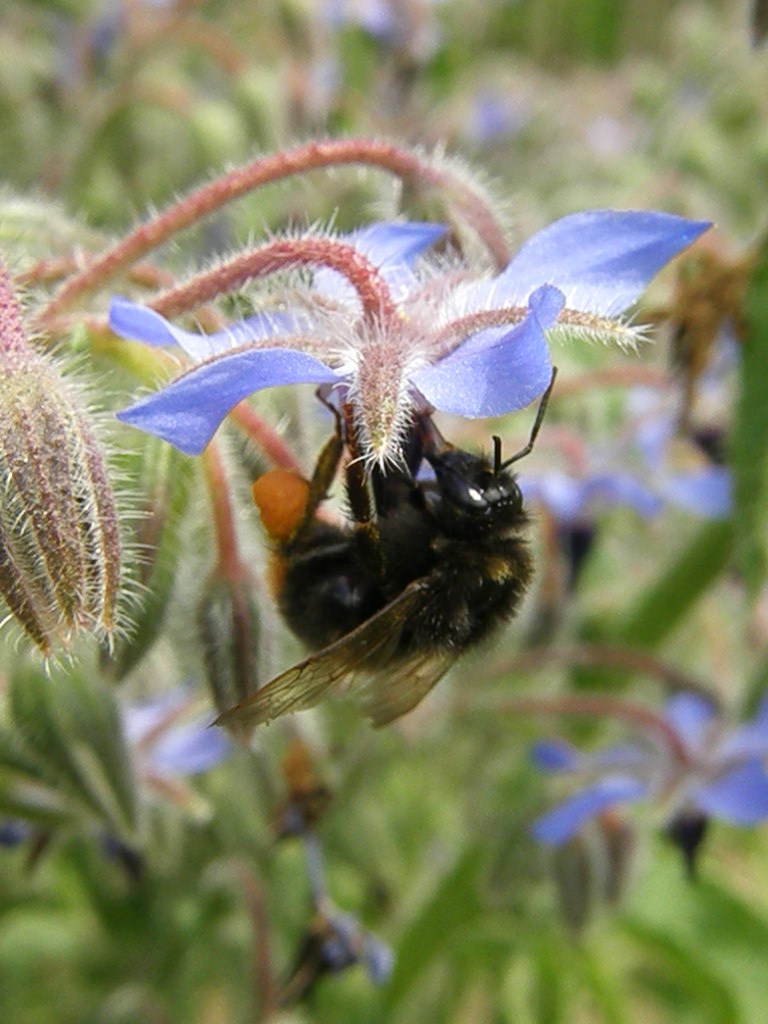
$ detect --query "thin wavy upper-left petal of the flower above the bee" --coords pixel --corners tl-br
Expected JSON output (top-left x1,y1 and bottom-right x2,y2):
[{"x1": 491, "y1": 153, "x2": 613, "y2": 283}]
[{"x1": 109, "y1": 296, "x2": 306, "y2": 360}]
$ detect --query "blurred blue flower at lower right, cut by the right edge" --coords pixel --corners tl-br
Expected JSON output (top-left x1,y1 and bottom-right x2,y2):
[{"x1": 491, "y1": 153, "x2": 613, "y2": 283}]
[{"x1": 531, "y1": 693, "x2": 768, "y2": 846}]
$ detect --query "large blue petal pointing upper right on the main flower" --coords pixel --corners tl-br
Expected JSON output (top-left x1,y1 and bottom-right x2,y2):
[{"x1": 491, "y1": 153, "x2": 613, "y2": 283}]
[{"x1": 497, "y1": 210, "x2": 711, "y2": 316}]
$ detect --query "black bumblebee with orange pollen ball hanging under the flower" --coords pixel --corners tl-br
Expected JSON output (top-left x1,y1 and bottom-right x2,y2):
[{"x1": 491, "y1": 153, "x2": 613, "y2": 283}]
[{"x1": 217, "y1": 373, "x2": 555, "y2": 726}]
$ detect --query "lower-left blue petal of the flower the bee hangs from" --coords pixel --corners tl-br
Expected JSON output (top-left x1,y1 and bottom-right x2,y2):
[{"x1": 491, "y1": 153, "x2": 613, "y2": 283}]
[{"x1": 118, "y1": 348, "x2": 341, "y2": 455}]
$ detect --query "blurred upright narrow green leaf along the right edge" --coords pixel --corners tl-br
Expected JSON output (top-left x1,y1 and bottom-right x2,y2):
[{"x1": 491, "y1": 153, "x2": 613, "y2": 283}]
[{"x1": 731, "y1": 240, "x2": 768, "y2": 598}]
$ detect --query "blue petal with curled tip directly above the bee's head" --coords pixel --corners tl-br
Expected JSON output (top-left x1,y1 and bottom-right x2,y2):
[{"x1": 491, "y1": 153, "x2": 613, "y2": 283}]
[{"x1": 411, "y1": 288, "x2": 562, "y2": 419}]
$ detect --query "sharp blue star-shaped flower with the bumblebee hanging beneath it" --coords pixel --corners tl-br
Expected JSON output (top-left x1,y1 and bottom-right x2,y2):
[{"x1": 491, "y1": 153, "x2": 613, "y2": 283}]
[{"x1": 110, "y1": 211, "x2": 709, "y2": 463}]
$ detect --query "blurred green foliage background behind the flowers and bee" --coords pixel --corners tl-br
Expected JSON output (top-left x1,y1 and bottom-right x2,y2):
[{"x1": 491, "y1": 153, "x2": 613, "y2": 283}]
[{"x1": 0, "y1": 0, "x2": 768, "y2": 1024}]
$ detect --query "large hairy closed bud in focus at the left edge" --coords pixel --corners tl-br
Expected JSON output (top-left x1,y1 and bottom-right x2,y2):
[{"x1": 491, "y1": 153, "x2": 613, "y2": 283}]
[{"x1": 0, "y1": 265, "x2": 120, "y2": 655}]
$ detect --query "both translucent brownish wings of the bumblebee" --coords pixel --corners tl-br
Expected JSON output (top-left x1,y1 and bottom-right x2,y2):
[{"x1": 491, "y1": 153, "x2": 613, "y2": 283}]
[{"x1": 216, "y1": 580, "x2": 454, "y2": 726}]
